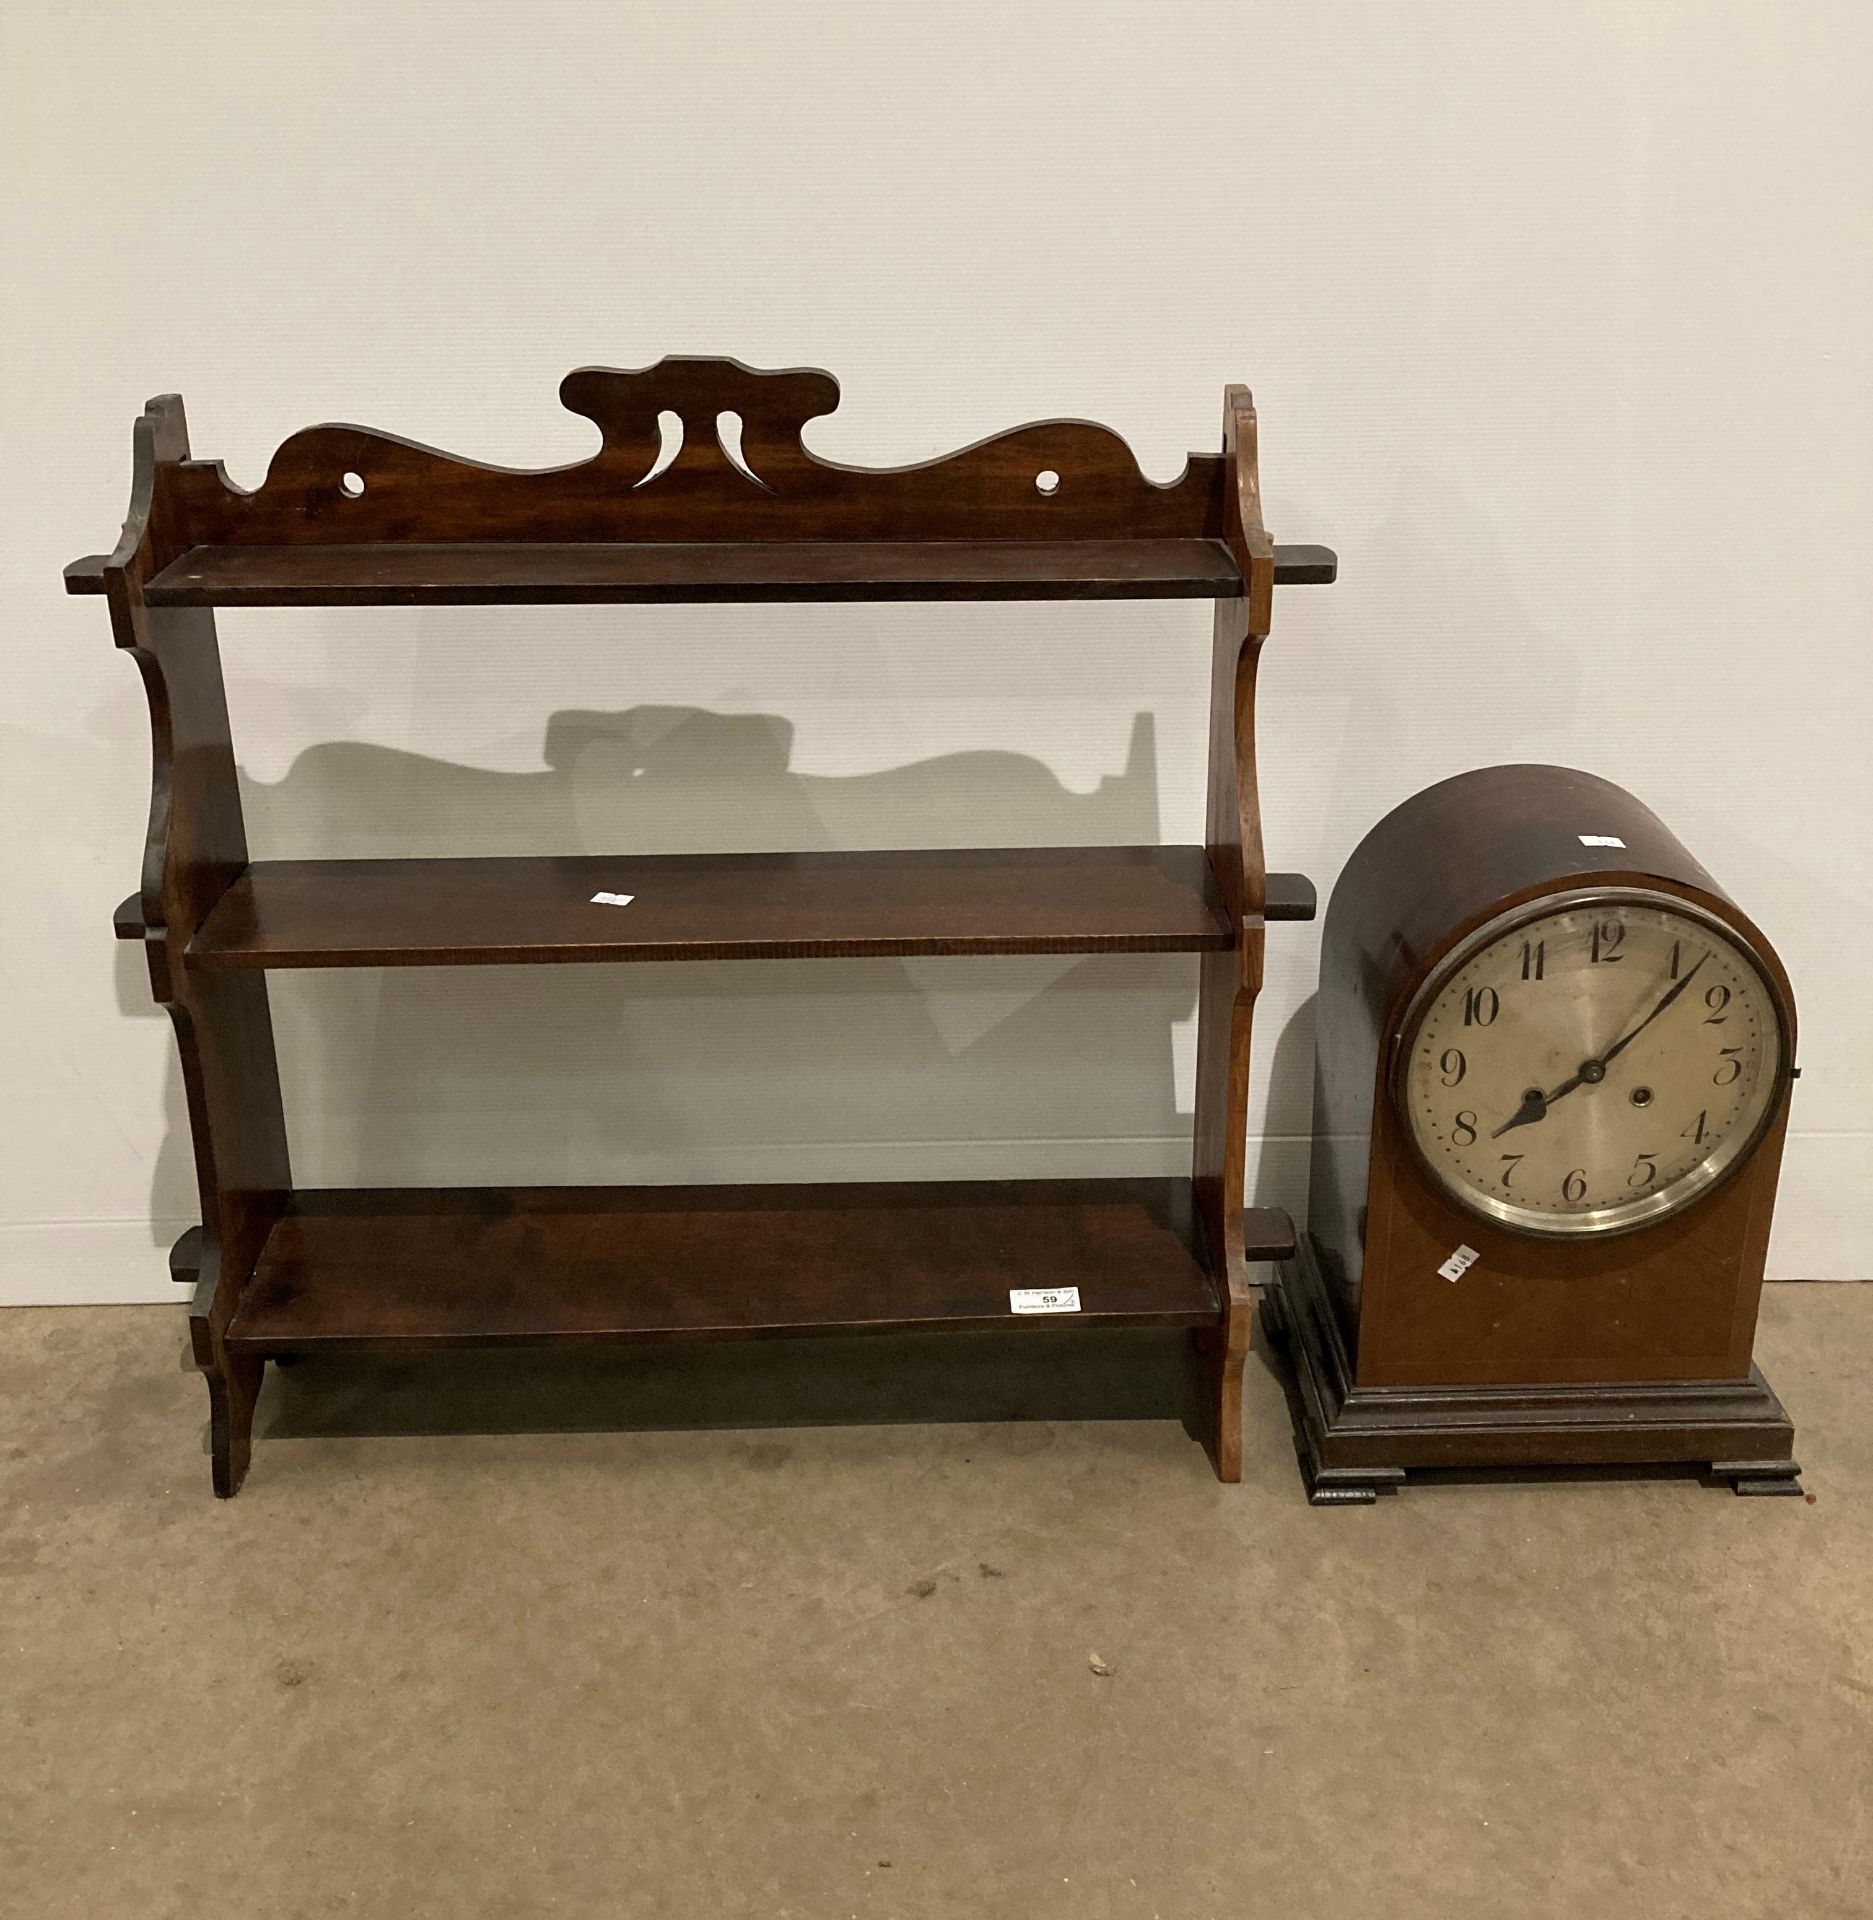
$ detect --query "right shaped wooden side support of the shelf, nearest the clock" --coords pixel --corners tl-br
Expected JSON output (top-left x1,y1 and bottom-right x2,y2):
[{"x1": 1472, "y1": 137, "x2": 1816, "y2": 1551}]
[{"x1": 1192, "y1": 386, "x2": 1274, "y2": 1480}]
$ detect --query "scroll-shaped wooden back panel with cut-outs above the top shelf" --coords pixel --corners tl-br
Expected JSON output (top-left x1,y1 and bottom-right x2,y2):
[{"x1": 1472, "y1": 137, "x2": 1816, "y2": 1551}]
[{"x1": 155, "y1": 359, "x2": 1232, "y2": 545}]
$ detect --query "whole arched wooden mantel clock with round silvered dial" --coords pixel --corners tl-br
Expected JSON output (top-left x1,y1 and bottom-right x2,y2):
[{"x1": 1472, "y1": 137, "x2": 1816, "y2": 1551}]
[{"x1": 1267, "y1": 766, "x2": 1800, "y2": 1501}]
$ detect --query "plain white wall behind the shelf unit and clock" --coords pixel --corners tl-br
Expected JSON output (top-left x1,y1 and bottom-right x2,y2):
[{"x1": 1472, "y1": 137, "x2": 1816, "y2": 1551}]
[{"x1": 0, "y1": 0, "x2": 1873, "y2": 1300}]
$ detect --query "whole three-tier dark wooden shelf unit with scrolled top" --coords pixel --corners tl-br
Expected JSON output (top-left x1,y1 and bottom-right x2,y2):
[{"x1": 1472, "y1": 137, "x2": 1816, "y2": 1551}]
[{"x1": 65, "y1": 359, "x2": 1334, "y2": 1496}]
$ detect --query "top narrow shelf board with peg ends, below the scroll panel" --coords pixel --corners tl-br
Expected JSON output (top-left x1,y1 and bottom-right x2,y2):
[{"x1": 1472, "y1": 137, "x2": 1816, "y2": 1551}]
[{"x1": 65, "y1": 540, "x2": 1338, "y2": 607}]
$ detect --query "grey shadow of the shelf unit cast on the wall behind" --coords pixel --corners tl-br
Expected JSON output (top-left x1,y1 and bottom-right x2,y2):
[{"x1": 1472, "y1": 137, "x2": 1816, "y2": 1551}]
[{"x1": 127, "y1": 707, "x2": 1327, "y2": 1212}]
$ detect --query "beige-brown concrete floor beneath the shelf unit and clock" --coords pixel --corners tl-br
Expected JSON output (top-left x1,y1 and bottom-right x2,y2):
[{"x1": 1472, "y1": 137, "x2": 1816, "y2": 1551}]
[{"x1": 0, "y1": 1286, "x2": 1873, "y2": 1920}]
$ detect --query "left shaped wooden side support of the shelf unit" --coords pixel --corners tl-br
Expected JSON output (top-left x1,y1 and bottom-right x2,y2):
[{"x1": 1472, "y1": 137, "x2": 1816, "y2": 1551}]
[{"x1": 102, "y1": 394, "x2": 292, "y2": 1498}]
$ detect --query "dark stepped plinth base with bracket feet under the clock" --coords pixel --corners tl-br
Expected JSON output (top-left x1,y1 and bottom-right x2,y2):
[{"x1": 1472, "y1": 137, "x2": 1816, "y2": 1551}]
[{"x1": 1263, "y1": 1235, "x2": 1802, "y2": 1505}]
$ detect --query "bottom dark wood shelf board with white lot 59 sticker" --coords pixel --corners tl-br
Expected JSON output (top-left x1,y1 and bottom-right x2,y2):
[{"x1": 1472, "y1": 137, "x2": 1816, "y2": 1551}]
[{"x1": 228, "y1": 1179, "x2": 1221, "y2": 1356}]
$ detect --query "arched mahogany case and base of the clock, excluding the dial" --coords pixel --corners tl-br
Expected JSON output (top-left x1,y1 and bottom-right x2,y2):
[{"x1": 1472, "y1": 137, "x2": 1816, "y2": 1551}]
[{"x1": 1265, "y1": 766, "x2": 1800, "y2": 1501}]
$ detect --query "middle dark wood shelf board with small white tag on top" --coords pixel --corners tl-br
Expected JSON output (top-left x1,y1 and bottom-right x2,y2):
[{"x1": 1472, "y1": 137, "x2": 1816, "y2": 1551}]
[{"x1": 188, "y1": 847, "x2": 1313, "y2": 970}]
